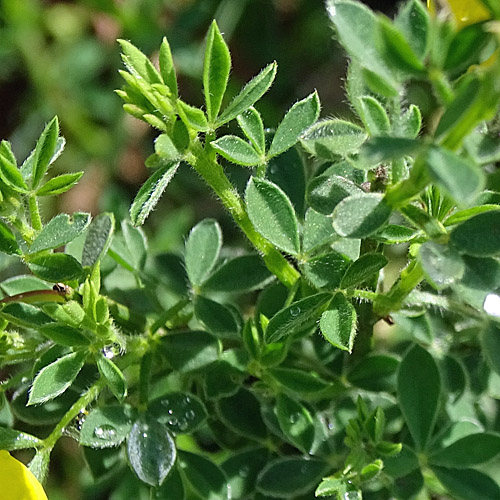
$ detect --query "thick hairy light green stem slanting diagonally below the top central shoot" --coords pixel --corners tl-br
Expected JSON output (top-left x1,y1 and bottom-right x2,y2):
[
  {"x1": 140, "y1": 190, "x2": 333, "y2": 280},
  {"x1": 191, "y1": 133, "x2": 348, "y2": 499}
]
[{"x1": 186, "y1": 141, "x2": 300, "y2": 288}]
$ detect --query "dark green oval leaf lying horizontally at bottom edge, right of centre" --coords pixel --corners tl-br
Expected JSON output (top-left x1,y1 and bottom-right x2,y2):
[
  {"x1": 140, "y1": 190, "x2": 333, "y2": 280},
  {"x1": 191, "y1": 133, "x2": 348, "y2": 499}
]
[{"x1": 257, "y1": 457, "x2": 330, "y2": 498}]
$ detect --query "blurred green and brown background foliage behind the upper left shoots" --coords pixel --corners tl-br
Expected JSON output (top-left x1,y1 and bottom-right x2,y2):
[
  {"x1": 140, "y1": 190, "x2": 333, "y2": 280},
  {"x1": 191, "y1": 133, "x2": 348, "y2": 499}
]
[{"x1": 0, "y1": 0, "x2": 395, "y2": 251}]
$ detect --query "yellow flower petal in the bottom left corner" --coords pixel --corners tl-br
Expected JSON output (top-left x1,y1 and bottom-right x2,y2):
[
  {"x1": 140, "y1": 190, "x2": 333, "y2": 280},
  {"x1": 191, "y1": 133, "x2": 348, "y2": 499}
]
[{"x1": 0, "y1": 450, "x2": 47, "y2": 500}]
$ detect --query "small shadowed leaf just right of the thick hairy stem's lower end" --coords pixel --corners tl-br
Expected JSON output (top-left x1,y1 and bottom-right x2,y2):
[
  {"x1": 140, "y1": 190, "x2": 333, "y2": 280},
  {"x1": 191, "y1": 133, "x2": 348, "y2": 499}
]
[{"x1": 303, "y1": 251, "x2": 349, "y2": 290}]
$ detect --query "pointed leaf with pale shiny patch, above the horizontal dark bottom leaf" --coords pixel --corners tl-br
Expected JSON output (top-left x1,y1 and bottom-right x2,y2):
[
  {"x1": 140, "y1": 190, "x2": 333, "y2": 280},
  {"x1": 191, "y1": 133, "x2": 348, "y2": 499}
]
[{"x1": 275, "y1": 394, "x2": 314, "y2": 453}]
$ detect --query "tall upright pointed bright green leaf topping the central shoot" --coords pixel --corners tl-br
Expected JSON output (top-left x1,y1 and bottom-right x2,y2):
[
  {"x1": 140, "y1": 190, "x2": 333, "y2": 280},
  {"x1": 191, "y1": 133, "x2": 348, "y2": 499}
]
[{"x1": 203, "y1": 20, "x2": 231, "y2": 123}]
